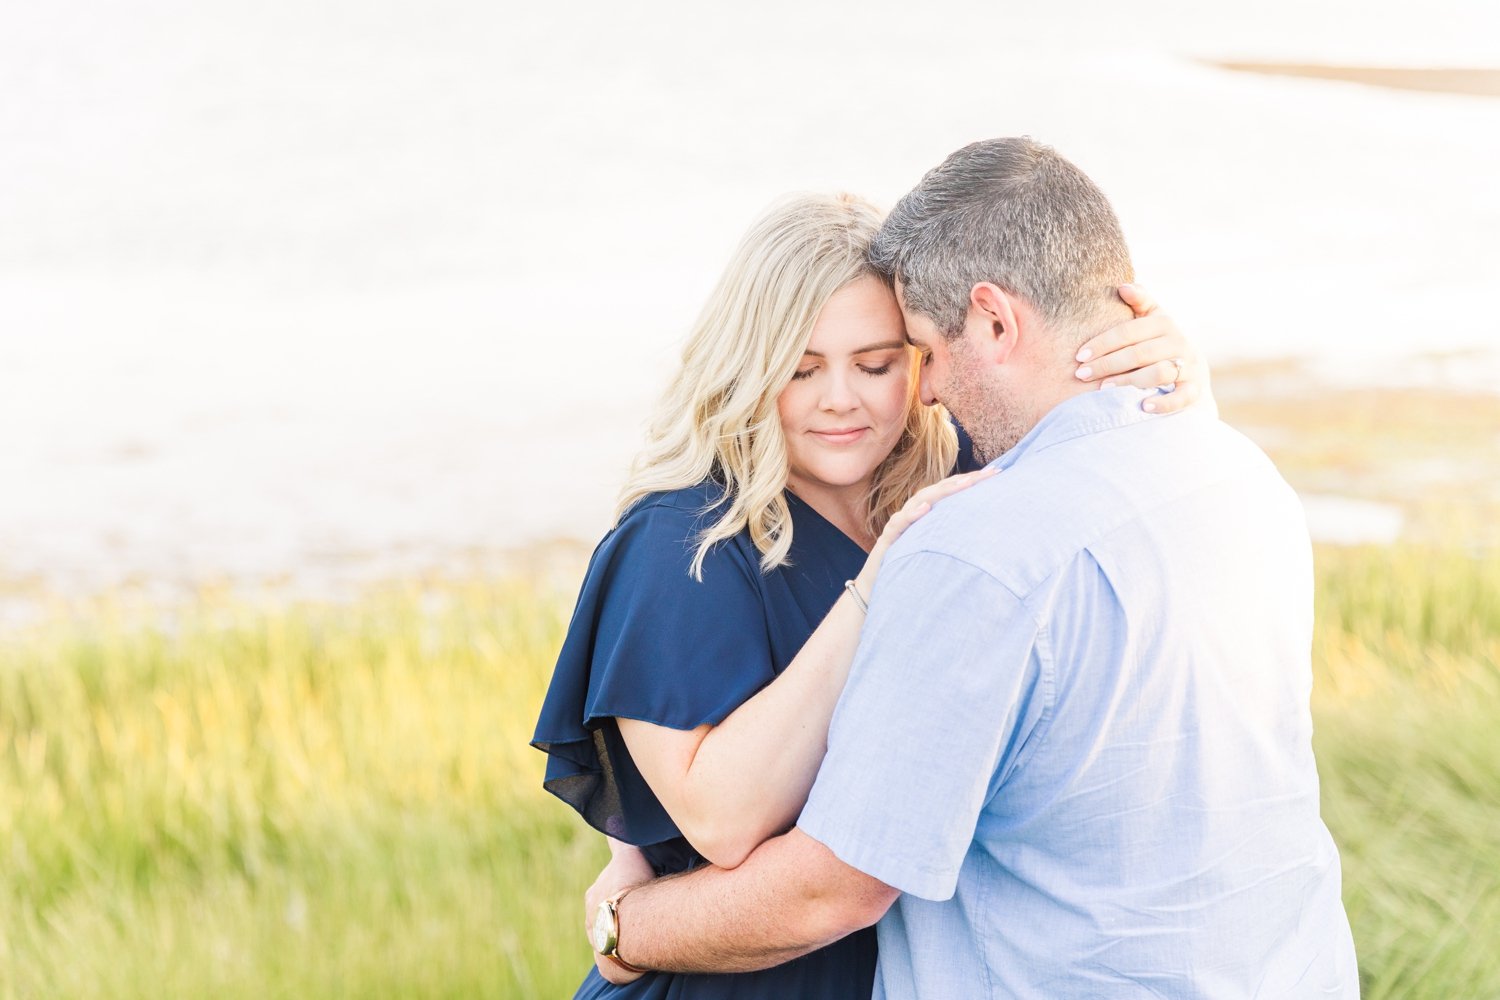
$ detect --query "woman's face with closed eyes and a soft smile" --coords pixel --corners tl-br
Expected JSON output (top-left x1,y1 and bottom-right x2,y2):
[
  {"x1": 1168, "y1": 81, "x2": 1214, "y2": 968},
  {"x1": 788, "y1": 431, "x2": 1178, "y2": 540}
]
[{"x1": 777, "y1": 277, "x2": 912, "y2": 501}]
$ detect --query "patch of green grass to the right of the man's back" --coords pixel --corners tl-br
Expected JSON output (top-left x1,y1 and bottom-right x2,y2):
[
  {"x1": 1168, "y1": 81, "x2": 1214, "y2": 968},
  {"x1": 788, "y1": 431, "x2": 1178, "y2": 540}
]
[{"x1": 1314, "y1": 549, "x2": 1500, "y2": 1000}]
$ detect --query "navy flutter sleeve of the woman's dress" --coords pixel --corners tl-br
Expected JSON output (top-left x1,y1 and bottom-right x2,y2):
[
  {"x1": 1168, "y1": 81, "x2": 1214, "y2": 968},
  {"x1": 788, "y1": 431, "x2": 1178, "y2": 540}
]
[{"x1": 531, "y1": 505, "x2": 776, "y2": 846}]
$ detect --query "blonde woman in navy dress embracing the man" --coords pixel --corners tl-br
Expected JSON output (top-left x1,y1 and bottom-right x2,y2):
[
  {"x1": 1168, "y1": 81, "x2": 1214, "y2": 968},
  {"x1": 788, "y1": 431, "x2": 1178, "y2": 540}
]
[{"x1": 533, "y1": 196, "x2": 1200, "y2": 1000}]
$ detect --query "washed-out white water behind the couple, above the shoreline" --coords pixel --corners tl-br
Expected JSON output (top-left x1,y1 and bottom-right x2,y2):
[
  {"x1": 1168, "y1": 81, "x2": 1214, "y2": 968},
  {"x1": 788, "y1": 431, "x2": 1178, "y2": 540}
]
[{"x1": 0, "y1": 0, "x2": 1500, "y2": 605}]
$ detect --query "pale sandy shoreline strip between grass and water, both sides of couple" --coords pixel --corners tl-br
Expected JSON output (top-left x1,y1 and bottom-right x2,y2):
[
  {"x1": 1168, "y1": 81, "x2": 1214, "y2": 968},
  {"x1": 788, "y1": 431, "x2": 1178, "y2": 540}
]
[{"x1": 0, "y1": 351, "x2": 1500, "y2": 636}]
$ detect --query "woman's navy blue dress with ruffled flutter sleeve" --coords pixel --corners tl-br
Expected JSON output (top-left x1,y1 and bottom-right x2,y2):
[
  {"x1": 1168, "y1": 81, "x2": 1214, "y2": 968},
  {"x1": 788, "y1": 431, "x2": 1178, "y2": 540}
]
[{"x1": 533, "y1": 483, "x2": 876, "y2": 1000}]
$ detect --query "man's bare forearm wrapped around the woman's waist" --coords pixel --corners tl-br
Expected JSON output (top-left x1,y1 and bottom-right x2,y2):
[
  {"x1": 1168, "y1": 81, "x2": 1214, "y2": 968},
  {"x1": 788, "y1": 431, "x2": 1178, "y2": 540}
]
[{"x1": 587, "y1": 828, "x2": 900, "y2": 973}]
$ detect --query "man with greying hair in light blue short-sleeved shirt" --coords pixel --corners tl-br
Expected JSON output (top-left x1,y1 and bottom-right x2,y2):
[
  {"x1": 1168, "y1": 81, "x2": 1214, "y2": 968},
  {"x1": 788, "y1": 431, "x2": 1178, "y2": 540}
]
[{"x1": 585, "y1": 138, "x2": 1358, "y2": 999}]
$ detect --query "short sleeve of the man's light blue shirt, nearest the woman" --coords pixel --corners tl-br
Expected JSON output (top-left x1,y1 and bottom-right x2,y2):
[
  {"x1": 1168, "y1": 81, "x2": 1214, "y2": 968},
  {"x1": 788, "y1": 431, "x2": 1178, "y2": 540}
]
[{"x1": 797, "y1": 552, "x2": 1052, "y2": 900}]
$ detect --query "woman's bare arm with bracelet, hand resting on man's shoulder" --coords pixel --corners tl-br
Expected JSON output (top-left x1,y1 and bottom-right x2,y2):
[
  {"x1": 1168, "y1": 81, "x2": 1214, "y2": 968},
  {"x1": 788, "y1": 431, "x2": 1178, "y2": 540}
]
[{"x1": 617, "y1": 469, "x2": 993, "y2": 868}]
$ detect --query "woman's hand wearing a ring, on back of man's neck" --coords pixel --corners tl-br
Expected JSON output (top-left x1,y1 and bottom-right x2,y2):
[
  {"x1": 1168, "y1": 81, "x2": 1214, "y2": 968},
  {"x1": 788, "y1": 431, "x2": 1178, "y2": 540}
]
[{"x1": 1076, "y1": 285, "x2": 1209, "y2": 414}]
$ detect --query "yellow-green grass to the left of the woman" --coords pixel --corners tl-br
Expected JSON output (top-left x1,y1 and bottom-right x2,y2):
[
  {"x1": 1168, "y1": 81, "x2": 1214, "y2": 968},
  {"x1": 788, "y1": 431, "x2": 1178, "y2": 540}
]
[{"x1": 0, "y1": 585, "x2": 600, "y2": 999}]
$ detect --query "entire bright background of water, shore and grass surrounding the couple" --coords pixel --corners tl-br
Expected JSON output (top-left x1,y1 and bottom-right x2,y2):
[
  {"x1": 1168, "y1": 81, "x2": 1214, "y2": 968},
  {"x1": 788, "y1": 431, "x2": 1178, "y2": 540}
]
[{"x1": 0, "y1": 0, "x2": 1500, "y2": 1000}]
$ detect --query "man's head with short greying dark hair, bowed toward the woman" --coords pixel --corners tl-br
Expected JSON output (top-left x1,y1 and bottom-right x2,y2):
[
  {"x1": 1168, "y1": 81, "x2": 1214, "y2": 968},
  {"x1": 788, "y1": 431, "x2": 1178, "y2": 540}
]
[{"x1": 870, "y1": 138, "x2": 1134, "y2": 459}]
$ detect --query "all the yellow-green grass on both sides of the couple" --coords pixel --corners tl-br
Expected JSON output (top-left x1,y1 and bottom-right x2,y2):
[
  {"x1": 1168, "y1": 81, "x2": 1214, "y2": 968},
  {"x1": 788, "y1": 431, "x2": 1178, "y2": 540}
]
[{"x1": 0, "y1": 549, "x2": 1500, "y2": 1000}]
